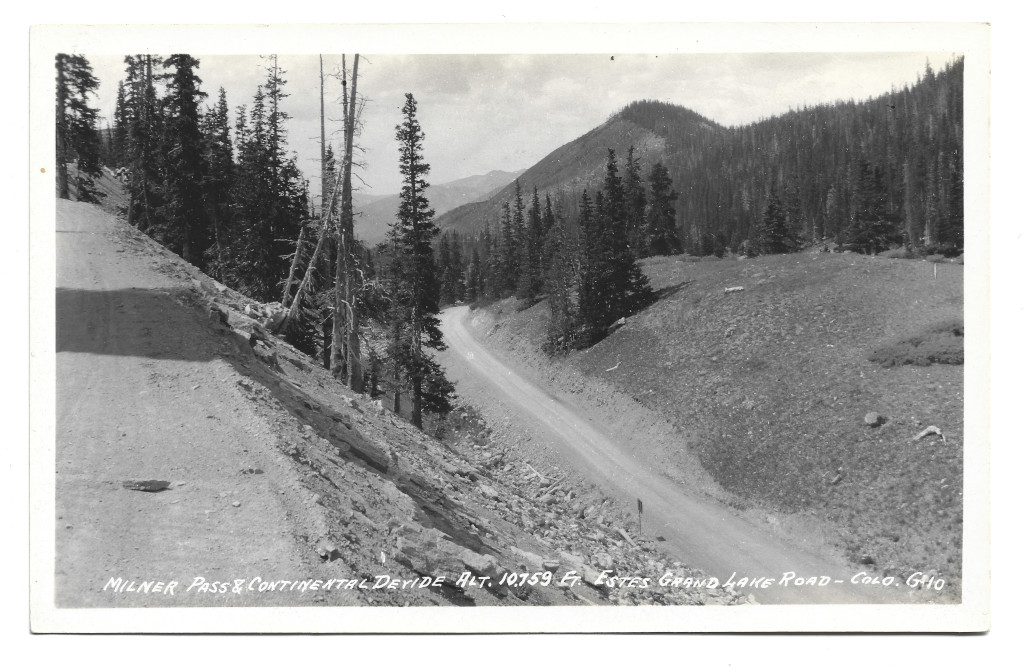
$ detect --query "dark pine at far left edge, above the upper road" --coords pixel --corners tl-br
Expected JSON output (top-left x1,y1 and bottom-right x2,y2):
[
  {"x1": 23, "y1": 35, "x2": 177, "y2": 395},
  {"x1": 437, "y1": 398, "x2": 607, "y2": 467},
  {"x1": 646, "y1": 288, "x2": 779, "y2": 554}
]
[{"x1": 55, "y1": 53, "x2": 102, "y2": 202}]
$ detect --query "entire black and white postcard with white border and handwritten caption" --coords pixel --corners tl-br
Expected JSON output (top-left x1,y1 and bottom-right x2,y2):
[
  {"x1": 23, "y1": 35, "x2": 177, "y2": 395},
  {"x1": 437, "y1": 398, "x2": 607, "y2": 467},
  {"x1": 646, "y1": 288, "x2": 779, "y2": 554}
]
[{"x1": 30, "y1": 24, "x2": 990, "y2": 633}]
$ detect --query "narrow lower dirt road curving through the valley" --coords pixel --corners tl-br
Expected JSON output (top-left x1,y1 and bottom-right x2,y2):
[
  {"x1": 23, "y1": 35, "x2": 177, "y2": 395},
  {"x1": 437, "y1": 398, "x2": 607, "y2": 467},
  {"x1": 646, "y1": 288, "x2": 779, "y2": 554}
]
[{"x1": 441, "y1": 306, "x2": 916, "y2": 603}]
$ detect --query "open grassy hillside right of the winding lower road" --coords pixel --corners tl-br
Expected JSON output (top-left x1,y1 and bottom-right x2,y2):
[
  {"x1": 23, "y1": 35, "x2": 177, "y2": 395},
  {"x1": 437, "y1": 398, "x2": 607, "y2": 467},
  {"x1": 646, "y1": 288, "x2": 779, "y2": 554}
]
[{"x1": 475, "y1": 253, "x2": 965, "y2": 581}]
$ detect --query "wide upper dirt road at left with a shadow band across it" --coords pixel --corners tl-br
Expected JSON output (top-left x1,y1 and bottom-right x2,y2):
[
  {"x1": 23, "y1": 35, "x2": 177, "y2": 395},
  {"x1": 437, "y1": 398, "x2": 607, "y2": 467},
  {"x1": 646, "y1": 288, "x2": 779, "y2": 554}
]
[{"x1": 55, "y1": 200, "x2": 335, "y2": 608}]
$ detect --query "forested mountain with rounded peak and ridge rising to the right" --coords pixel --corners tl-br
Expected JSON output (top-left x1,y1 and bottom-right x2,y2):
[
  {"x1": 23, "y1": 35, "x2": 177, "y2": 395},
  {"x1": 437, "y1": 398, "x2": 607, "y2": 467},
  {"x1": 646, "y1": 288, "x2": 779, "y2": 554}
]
[{"x1": 438, "y1": 58, "x2": 964, "y2": 255}]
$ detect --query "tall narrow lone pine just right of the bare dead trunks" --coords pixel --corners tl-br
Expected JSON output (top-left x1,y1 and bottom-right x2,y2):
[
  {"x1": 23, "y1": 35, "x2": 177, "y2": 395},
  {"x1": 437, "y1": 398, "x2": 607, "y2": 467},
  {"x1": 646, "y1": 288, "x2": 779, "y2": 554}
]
[{"x1": 388, "y1": 93, "x2": 453, "y2": 428}]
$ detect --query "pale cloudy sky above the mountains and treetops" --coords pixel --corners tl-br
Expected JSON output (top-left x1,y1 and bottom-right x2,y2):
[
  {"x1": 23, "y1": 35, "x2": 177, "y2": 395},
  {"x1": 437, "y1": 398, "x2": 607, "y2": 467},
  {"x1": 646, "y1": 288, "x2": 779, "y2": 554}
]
[{"x1": 85, "y1": 51, "x2": 954, "y2": 195}]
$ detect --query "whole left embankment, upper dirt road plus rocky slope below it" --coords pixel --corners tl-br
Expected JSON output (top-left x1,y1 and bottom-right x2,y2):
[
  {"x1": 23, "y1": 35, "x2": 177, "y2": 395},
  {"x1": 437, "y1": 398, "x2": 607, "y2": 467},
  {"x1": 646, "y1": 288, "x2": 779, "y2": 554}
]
[{"x1": 54, "y1": 201, "x2": 742, "y2": 608}]
